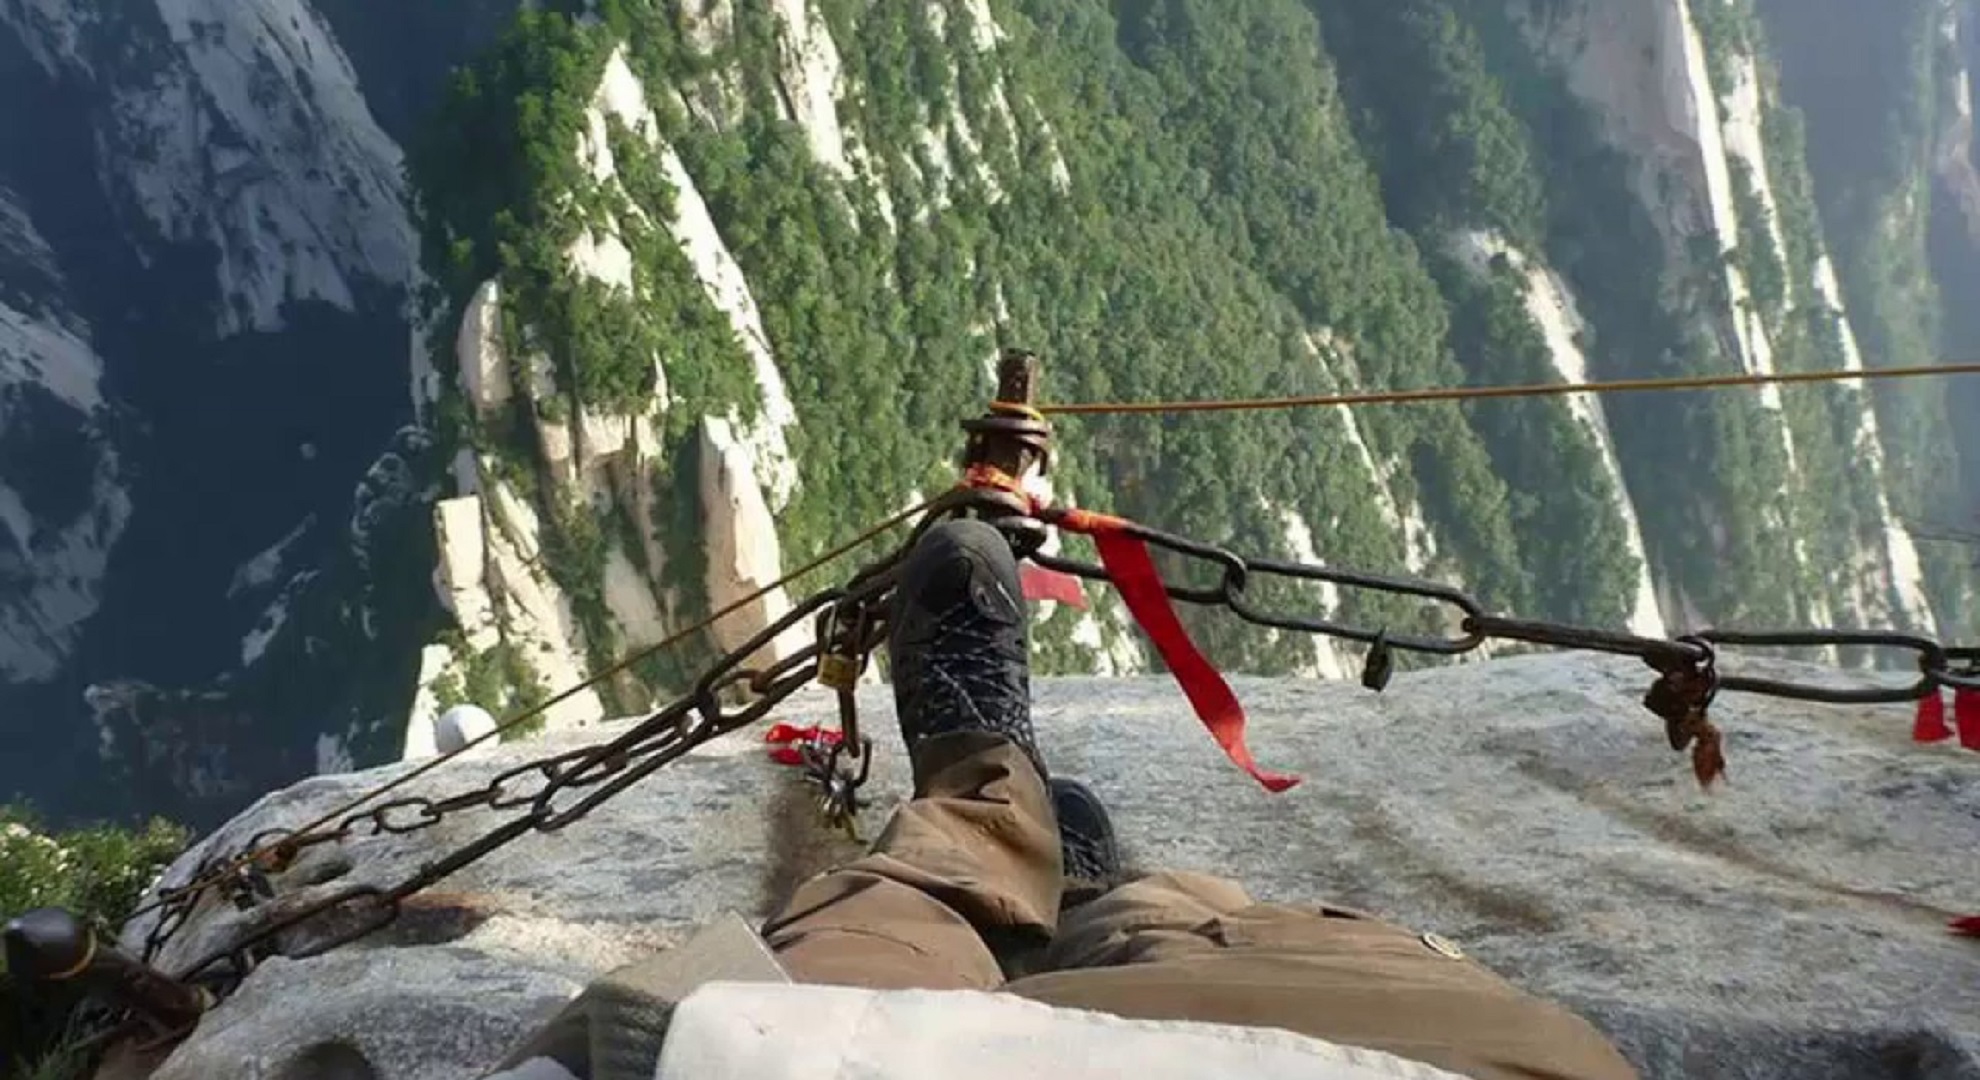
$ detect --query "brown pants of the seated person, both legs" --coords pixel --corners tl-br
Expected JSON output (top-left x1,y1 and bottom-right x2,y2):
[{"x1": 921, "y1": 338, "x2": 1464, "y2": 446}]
[{"x1": 764, "y1": 733, "x2": 1635, "y2": 1080}]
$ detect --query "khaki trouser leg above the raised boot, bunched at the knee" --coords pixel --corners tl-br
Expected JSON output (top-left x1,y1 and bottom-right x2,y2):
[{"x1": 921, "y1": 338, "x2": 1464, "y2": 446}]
[{"x1": 764, "y1": 731, "x2": 1063, "y2": 989}]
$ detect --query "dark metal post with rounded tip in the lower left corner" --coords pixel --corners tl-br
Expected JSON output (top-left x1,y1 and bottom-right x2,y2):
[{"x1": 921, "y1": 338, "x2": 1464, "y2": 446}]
[{"x1": 0, "y1": 908, "x2": 214, "y2": 1036}]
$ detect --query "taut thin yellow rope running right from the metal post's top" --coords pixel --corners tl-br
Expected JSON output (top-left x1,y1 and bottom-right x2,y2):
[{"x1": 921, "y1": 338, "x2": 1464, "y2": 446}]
[{"x1": 994, "y1": 363, "x2": 1980, "y2": 416}]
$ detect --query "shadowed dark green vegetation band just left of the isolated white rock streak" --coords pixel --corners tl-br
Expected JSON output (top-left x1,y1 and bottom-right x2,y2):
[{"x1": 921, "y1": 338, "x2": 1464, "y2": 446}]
[{"x1": 1315, "y1": 0, "x2": 1639, "y2": 624}]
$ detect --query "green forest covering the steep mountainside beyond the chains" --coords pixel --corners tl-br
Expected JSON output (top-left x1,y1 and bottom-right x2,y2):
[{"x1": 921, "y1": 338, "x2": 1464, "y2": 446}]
[{"x1": 408, "y1": 0, "x2": 1972, "y2": 690}]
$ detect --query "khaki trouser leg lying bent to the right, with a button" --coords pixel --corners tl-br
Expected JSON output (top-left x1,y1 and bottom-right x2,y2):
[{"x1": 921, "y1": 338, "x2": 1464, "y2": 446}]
[{"x1": 1006, "y1": 874, "x2": 1635, "y2": 1080}]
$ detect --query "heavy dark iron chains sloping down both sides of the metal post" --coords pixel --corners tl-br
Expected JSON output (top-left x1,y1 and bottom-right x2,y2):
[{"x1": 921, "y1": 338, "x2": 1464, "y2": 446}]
[{"x1": 131, "y1": 479, "x2": 1980, "y2": 995}]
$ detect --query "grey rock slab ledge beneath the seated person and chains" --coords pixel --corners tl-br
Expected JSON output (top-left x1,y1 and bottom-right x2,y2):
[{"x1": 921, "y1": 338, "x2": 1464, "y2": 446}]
[{"x1": 127, "y1": 656, "x2": 1980, "y2": 1080}]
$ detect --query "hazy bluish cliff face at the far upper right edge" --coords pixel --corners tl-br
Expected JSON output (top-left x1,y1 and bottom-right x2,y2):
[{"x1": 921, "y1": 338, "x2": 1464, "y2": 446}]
[{"x1": 1760, "y1": 0, "x2": 1980, "y2": 614}]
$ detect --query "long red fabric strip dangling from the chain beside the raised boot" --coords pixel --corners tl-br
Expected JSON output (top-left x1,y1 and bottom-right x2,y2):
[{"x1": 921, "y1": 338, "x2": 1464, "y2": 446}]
[{"x1": 1059, "y1": 509, "x2": 1299, "y2": 791}]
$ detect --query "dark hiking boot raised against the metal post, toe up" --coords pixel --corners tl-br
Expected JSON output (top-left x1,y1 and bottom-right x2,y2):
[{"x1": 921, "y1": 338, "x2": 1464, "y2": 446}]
[{"x1": 887, "y1": 519, "x2": 1045, "y2": 779}]
